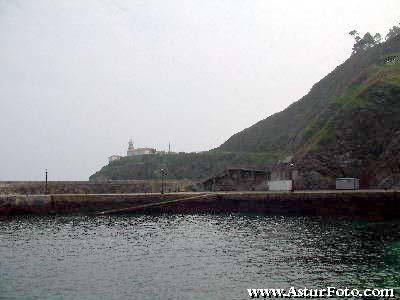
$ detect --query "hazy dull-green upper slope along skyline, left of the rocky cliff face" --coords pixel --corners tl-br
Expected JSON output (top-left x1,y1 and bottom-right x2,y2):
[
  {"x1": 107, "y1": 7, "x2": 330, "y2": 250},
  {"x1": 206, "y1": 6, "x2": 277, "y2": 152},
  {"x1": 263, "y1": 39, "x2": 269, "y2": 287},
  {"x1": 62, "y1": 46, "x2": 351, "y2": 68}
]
[{"x1": 218, "y1": 38, "x2": 400, "y2": 157}]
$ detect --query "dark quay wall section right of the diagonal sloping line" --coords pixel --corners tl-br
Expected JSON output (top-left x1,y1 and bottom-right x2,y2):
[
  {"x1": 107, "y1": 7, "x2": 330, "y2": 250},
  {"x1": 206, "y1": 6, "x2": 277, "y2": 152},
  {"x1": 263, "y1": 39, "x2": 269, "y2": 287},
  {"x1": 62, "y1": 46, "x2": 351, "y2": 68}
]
[{"x1": 126, "y1": 191, "x2": 400, "y2": 221}]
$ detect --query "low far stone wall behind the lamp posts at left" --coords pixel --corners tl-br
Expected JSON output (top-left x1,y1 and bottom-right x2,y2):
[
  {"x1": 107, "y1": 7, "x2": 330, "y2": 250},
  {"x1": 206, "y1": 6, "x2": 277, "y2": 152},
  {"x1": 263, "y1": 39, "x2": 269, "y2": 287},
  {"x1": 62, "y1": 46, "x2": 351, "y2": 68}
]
[{"x1": 0, "y1": 180, "x2": 193, "y2": 195}]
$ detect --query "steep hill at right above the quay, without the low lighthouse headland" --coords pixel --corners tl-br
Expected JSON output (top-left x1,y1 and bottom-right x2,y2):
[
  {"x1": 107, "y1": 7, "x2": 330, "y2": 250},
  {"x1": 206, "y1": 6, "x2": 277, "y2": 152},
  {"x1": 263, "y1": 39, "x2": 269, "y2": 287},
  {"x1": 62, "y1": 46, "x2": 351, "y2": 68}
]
[{"x1": 219, "y1": 37, "x2": 400, "y2": 187}]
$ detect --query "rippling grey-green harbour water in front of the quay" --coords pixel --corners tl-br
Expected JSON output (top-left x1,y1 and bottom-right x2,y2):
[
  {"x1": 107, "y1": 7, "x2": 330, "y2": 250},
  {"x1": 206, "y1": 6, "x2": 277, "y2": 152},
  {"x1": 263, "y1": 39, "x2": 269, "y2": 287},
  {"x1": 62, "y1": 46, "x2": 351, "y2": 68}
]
[{"x1": 0, "y1": 215, "x2": 400, "y2": 299}]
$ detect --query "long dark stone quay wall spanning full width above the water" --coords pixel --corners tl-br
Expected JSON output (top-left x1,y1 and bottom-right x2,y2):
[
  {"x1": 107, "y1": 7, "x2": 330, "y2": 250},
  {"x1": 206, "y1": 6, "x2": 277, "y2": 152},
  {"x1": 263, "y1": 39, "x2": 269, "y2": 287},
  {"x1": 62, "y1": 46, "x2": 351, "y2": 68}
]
[{"x1": 0, "y1": 190, "x2": 400, "y2": 220}]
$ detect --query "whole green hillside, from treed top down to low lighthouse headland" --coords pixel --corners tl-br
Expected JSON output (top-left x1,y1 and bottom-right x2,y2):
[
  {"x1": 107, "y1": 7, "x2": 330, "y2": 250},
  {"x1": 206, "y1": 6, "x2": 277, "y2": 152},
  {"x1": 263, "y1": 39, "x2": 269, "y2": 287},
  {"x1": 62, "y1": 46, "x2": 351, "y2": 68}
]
[{"x1": 91, "y1": 27, "x2": 400, "y2": 188}]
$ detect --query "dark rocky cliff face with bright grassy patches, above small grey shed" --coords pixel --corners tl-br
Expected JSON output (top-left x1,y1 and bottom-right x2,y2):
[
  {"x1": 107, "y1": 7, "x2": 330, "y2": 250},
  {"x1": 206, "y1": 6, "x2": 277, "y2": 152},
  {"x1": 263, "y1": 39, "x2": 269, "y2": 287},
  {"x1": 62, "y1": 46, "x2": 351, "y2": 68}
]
[{"x1": 296, "y1": 64, "x2": 400, "y2": 186}]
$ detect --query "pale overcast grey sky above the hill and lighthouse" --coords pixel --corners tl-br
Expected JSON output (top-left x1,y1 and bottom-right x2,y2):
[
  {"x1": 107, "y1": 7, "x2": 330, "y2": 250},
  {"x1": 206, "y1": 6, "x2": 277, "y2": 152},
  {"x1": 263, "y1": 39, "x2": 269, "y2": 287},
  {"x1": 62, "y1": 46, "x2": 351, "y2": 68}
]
[{"x1": 0, "y1": 0, "x2": 400, "y2": 180}]
